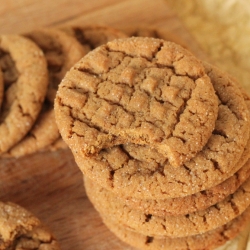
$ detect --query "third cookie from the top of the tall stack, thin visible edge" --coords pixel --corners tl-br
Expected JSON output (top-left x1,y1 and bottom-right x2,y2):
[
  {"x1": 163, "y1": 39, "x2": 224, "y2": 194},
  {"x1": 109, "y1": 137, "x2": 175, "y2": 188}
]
[{"x1": 123, "y1": 156, "x2": 250, "y2": 216}]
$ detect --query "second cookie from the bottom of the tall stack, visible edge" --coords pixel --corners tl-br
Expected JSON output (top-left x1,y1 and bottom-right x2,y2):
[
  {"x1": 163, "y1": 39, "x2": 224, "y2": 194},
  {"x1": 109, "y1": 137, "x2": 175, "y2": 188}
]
[{"x1": 84, "y1": 173, "x2": 250, "y2": 237}]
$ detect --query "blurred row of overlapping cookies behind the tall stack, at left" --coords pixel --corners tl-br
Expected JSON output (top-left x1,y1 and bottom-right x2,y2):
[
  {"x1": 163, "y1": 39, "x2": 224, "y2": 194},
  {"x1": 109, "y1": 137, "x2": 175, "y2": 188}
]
[{"x1": 0, "y1": 26, "x2": 126, "y2": 157}]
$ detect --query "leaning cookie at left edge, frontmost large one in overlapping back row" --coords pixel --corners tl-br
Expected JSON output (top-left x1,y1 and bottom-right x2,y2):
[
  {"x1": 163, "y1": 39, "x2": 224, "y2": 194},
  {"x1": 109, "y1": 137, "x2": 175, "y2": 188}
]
[{"x1": 0, "y1": 35, "x2": 48, "y2": 153}]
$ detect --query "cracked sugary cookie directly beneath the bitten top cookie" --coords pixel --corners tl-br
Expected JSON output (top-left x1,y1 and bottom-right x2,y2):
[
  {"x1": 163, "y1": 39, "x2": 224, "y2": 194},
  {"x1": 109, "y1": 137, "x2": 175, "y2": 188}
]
[{"x1": 65, "y1": 59, "x2": 249, "y2": 199}]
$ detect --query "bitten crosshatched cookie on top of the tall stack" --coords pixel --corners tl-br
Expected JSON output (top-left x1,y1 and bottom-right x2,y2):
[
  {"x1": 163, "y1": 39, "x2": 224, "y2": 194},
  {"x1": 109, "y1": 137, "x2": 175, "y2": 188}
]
[{"x1": 55, "y1": 37, "x2": 218, "y2": 167}]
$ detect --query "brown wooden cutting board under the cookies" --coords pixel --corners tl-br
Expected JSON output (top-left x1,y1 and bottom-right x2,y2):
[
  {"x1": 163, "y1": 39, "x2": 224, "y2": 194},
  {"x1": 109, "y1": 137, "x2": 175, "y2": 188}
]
[{"x1": 0, "y1": 0, "x2": 247, "y2": 250}]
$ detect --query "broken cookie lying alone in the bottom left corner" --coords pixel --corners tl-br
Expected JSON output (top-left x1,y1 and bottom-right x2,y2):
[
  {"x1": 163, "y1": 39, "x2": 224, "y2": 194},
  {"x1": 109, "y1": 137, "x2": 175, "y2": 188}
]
[{"x1": 0, "y1": 202, "x2": 61, "y2": 250}]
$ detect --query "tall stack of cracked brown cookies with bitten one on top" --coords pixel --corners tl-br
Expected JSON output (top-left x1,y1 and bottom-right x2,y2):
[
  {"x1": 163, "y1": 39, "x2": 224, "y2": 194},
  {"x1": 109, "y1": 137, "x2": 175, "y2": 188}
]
[{"x1": 55, "y1": 37, "x2": 250, "y2": 250}]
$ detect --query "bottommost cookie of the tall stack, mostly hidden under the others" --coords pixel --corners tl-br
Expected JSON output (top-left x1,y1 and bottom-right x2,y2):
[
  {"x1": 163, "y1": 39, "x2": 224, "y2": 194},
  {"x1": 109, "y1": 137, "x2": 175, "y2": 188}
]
[{"x1": 102, "y1": 205, "x2": 250, "y2": 250}]
